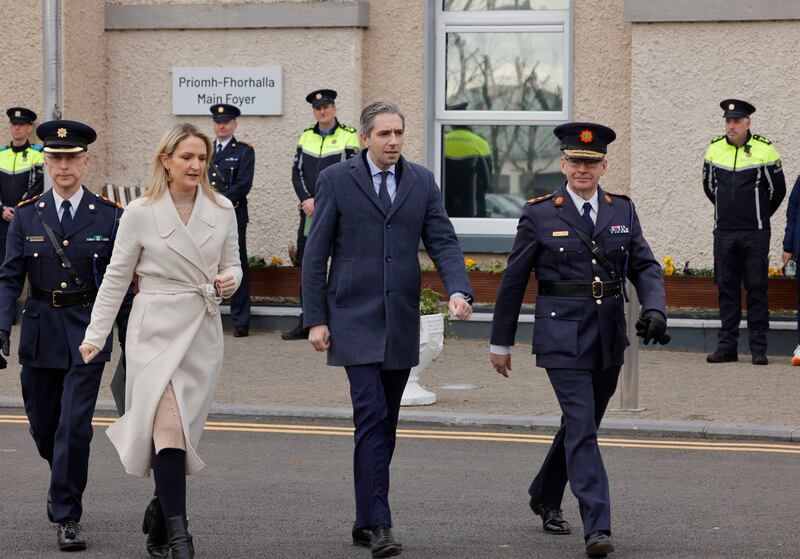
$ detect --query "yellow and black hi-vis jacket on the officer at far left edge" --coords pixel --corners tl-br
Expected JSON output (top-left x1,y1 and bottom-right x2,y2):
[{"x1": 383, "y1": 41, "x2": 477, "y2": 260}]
[{"x1": 0, "y1": 143, "x2": 44, "y2": 212}]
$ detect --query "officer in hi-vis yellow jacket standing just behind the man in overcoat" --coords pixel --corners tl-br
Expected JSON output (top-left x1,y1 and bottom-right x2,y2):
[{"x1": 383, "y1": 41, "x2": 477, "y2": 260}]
[{"x1": 281, "y1": 89, "x2": 359, "y2": 340}]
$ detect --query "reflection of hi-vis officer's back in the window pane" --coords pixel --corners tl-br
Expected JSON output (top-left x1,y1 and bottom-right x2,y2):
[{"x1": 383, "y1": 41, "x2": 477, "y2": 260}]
[{"x1": 443, "y1": 102, "x2": 490, "y2": 217}]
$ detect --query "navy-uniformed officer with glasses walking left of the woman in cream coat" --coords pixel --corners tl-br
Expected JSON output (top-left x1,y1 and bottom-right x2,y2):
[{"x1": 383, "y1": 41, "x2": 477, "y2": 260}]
[{"x1": 0, "y1": 120, "x2": 131, "y2": 551}]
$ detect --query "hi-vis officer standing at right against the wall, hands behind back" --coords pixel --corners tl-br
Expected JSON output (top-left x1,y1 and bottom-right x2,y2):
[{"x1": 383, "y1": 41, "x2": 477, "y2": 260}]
[{"x1": 703, "y1": 99, "x2": 786, "y2": 365}]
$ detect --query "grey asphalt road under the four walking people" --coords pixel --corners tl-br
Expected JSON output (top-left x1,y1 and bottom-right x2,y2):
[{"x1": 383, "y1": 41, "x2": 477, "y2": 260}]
[{"x1": 0, "y1": 409, "x2": 800, "y2": 559}]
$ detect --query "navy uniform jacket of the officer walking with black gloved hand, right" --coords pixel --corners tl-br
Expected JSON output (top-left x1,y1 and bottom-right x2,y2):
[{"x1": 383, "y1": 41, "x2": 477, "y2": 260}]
[{"x1": 491, "y1": 185, "x2": 666, "y2": 369}]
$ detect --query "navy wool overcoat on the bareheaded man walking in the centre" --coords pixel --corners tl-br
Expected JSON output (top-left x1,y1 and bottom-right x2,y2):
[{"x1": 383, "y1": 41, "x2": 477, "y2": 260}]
[{"x1": 303, "y1": 150, "x2": 472, "y2": 369}]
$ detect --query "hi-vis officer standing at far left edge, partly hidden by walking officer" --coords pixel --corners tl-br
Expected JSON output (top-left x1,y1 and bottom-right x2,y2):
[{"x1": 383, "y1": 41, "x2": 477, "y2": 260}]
[{"x1": 0, "y1": 107, "x2": 44, "y2": 263}]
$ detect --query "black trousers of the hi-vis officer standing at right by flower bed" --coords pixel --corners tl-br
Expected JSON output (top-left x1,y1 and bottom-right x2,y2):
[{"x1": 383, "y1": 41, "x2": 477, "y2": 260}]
[{"x1": 714, "y1": 229, "x2": 770, "y2": 352}]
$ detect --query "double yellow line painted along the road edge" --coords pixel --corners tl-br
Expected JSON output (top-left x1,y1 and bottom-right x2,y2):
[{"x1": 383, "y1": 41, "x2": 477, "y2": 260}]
[{"x1": 0, "y1": 414, "x2": 800, "y2": 454}]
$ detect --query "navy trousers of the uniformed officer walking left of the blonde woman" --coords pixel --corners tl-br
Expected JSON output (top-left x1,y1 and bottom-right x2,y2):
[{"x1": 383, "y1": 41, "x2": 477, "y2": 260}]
[{"x1": 20, "y1": 363, "x2": 105, "y2": 522}]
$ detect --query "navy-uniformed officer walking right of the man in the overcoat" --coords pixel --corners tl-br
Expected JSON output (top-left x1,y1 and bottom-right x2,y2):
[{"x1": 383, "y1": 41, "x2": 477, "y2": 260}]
[{"x1": 490, "y1": 122, "x2": 669, "y2": 557}]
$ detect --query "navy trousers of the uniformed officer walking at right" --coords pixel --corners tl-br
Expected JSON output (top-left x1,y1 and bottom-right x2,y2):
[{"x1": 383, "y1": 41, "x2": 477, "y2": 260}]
[{"x1": 529, "y1": 367, "x2": 620, "y2": 535}]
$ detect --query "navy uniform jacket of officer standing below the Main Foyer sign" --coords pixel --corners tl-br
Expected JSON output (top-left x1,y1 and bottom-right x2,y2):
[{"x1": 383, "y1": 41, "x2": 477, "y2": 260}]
[{"x1": 208, "y1": 137, "x2": 256, "y2": 223}]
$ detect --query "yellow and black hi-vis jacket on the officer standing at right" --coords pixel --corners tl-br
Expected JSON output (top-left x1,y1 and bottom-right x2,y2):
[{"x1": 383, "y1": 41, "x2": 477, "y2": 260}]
[{"x1": 703, "y1": 132, "x2": 786, "y2": 229}]
